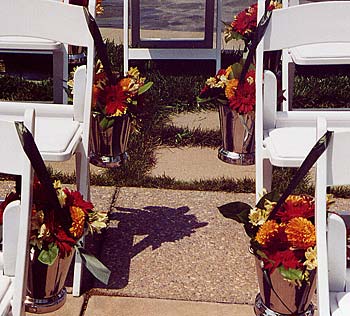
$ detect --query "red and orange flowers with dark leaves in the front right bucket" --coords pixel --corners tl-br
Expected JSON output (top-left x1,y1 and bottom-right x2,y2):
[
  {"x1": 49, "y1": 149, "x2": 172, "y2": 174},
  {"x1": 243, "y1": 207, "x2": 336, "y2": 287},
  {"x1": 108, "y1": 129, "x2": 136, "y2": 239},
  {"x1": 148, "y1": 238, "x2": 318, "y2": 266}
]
[{"x1": 219, "y1": 193, "x2": 333, "y2": 287}]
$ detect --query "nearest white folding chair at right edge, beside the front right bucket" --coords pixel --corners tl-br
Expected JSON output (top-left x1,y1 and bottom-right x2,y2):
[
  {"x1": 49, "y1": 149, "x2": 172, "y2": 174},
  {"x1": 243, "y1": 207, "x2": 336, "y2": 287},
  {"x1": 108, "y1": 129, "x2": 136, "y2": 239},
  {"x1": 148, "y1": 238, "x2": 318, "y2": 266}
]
[{"x1": 315, "y1": 117, "x2": 350, "y2": 316}]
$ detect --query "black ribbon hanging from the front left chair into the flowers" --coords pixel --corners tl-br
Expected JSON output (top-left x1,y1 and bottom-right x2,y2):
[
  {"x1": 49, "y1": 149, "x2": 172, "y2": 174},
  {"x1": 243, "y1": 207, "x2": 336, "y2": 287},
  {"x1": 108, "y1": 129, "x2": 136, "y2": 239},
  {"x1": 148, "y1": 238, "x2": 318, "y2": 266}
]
[{"x1": 15, "y1": 122, "x2": 61, "y2": 210}]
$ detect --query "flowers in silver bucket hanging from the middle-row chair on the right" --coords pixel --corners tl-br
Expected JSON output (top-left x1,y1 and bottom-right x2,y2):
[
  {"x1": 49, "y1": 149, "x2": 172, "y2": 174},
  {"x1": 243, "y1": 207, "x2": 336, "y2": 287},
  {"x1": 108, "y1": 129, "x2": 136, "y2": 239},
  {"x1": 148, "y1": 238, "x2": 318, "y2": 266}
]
[{"x1": 198, "y1": 60, "x2": 255, "y2": 115}]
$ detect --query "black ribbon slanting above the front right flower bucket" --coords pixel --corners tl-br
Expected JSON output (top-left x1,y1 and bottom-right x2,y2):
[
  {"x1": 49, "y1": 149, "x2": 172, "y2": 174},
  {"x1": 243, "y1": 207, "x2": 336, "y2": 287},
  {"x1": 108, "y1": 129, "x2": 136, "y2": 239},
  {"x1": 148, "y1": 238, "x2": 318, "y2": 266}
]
[{"x1": 269, "y1": 131, "x2": 333, "y2": 218}]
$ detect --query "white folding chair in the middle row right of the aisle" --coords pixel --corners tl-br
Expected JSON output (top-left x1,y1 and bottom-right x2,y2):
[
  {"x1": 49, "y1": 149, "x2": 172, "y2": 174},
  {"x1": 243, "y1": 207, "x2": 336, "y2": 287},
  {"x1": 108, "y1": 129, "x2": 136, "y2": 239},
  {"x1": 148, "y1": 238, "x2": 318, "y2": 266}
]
[{"x1": 255, "y1": 0, "x2": 350, "y2": 195}]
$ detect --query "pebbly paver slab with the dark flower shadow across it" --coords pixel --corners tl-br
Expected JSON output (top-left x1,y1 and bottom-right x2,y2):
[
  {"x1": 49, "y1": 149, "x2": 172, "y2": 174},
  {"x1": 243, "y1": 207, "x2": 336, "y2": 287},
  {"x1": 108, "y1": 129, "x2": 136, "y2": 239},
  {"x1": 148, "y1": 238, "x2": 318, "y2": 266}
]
[{"x1": 92, "y1": 188, "x2": 257, "y2": 304}]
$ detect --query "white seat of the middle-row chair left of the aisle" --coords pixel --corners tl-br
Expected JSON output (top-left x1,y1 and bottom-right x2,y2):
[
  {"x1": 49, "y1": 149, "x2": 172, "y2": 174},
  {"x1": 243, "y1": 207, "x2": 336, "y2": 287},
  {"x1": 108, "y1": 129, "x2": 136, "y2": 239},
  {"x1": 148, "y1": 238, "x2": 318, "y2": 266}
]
[{"x1": 35, "y1": 117, "x2": 82, "y2": 161}]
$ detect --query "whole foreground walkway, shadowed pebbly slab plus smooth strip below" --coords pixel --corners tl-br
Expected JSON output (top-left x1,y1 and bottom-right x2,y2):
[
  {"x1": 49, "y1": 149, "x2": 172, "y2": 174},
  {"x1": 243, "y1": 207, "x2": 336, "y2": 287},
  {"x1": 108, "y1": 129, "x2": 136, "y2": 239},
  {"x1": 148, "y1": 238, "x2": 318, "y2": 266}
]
[{"x1": 23, "y1": 183, "x2": 334, "y2": 316}]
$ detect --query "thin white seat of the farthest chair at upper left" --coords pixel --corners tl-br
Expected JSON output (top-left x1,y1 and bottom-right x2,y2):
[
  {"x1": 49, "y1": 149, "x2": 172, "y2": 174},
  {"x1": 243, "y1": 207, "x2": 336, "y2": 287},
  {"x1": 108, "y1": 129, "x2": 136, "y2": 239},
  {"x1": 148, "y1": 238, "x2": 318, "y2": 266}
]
[{"x1": 0, "y1": 36, "x2": 62, "y2": 51}]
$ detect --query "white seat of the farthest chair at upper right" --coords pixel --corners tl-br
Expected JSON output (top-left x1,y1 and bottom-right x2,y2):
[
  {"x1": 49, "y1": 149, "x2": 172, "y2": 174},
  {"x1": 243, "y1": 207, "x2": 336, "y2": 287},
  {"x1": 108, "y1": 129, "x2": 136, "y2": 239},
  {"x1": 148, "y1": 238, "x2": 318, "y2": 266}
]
[{"x1": 289, "y1": 43, "x2": 350, "y2": 65}]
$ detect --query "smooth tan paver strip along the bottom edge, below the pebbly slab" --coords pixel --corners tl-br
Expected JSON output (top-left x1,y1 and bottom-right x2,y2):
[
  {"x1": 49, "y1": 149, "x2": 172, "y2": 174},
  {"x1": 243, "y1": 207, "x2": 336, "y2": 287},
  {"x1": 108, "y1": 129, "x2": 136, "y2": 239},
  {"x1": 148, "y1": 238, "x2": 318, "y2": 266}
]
[{"x1": 84, "y1": 296, "x2": 254, "y2": 316}]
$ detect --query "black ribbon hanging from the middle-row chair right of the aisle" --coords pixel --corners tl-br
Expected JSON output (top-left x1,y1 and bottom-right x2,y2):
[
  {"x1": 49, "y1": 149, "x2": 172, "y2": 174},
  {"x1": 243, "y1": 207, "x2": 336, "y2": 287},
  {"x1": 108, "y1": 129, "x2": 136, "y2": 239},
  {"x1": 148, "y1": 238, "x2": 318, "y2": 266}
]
[{"x1": 239, "y1": 0, "x2": 272, "y2": 84}]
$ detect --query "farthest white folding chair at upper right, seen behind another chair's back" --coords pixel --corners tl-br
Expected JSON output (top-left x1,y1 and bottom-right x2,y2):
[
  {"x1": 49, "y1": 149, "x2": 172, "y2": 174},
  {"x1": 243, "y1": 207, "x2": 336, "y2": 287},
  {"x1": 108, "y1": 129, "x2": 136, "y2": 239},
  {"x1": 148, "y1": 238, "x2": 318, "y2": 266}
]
[{"x1": 282, "y1": 0, "x2": 350, "y2": 110}]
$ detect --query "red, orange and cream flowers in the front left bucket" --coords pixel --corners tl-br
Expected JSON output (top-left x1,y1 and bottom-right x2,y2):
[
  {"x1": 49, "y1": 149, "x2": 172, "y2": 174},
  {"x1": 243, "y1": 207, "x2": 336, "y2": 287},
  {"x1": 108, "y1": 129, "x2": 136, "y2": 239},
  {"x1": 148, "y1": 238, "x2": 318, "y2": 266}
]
[{"x1": 0, "y1": 179, "x2": 108, "y2": 265}]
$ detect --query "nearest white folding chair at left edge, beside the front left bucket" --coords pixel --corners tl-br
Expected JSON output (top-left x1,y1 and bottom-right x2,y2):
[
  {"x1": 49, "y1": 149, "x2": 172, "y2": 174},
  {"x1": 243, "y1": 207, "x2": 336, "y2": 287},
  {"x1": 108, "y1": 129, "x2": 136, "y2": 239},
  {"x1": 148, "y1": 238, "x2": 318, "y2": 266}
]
[{"x1": 0, "y1": 109, "x2": 34, "y2": 316}]
